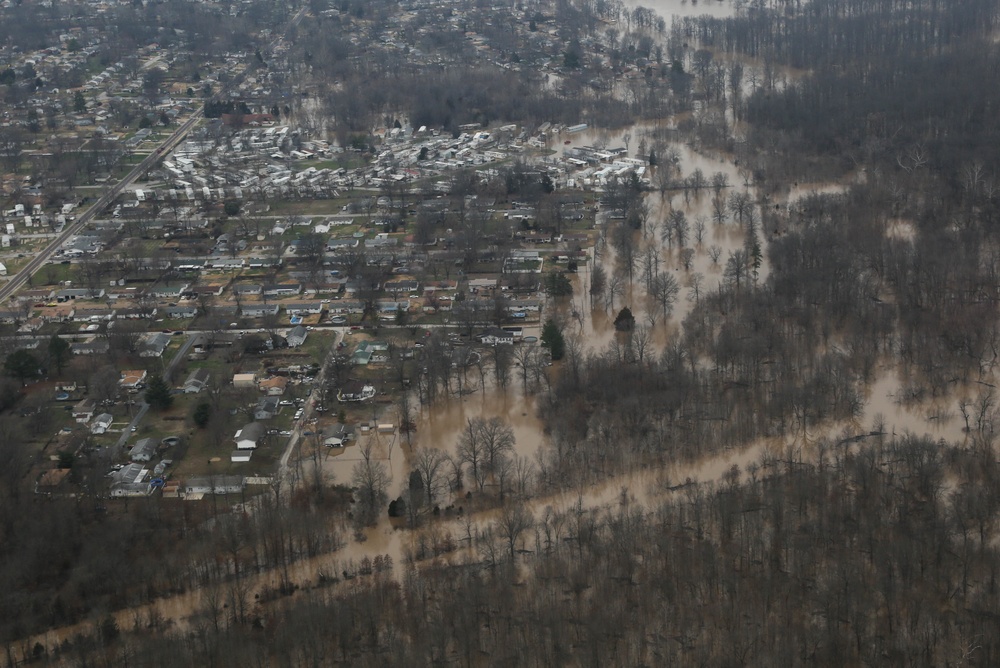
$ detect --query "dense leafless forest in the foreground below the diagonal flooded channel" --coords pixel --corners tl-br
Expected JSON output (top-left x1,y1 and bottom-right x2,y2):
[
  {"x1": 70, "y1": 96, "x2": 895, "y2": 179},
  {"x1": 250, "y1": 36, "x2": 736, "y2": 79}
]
[{"x1": 56, "y1": 436, "x2": 1000, "y2": 666}]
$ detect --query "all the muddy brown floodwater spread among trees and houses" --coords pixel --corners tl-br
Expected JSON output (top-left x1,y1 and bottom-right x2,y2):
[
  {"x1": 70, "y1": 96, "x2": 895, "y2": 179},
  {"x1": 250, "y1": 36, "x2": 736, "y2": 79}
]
[{"x1": 28, "y1": 0, "x2": 984, "y2": 649}]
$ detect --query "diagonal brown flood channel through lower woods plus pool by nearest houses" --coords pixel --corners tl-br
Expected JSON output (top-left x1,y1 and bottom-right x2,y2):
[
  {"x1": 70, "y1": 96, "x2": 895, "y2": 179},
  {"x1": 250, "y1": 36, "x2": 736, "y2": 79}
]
[{"x1": 26, "y1": 358, "x2": 964, "y2": 660}]
